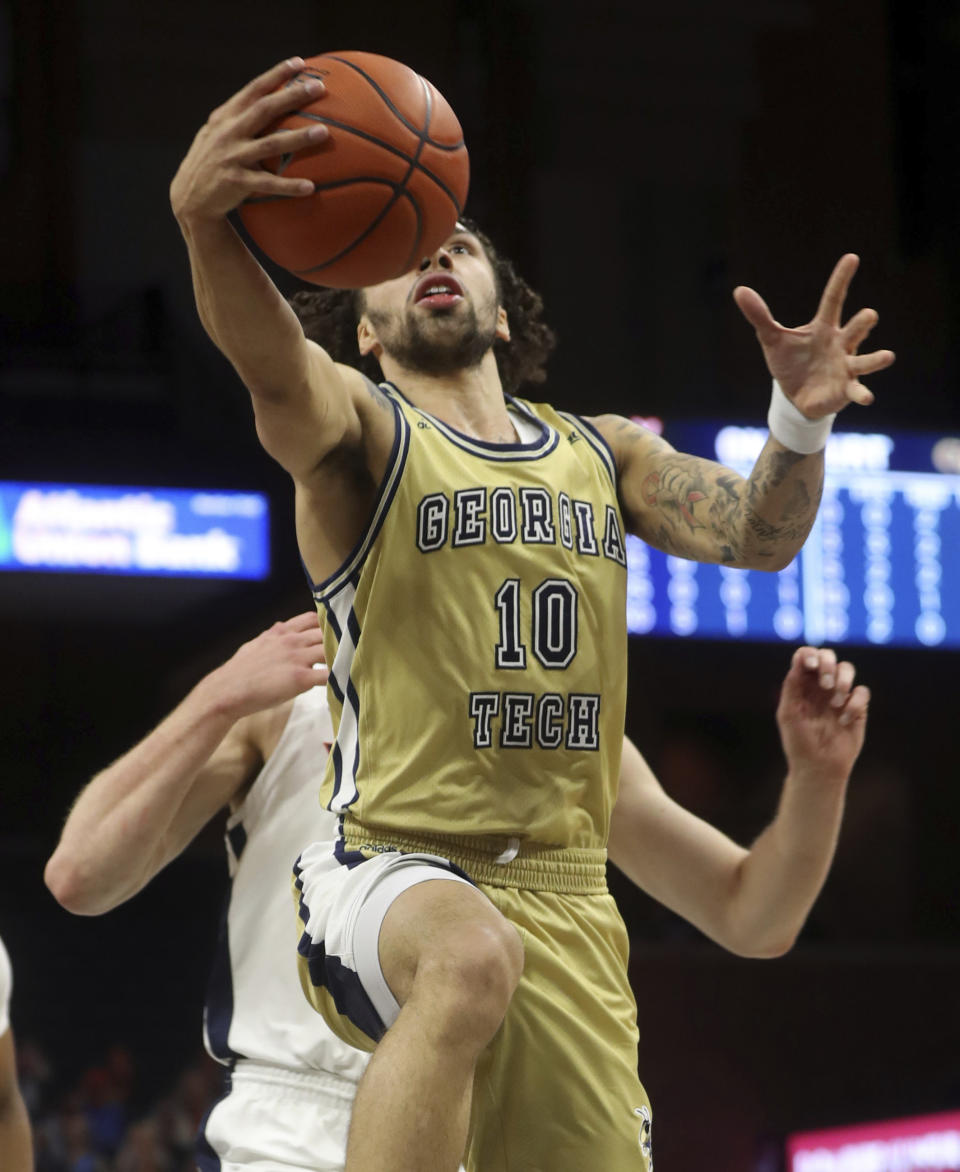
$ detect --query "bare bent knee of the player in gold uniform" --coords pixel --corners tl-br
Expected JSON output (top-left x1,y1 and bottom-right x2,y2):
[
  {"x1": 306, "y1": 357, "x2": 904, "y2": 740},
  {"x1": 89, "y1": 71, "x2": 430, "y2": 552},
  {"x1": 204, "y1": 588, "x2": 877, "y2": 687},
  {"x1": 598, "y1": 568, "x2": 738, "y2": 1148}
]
[{"x1": 417, "y1": 920, "x2": 523, "y2": 1047}]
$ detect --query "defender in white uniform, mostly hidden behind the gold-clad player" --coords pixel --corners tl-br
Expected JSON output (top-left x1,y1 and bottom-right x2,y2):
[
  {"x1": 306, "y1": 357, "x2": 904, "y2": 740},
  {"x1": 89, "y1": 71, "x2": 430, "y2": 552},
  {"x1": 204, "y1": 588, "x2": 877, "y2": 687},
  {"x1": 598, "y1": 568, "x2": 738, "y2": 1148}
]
[{"x1": 45, "y1": 614, "x2": 869, "y2": 1172}]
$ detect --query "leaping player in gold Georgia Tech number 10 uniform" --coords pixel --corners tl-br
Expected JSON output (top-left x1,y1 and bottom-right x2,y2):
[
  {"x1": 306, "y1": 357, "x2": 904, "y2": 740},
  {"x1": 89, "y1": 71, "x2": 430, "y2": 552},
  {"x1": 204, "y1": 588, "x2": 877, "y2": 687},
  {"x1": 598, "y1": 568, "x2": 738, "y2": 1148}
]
[{"x1": 171, "y1": 59, "x2": 893, "y2": 1172}]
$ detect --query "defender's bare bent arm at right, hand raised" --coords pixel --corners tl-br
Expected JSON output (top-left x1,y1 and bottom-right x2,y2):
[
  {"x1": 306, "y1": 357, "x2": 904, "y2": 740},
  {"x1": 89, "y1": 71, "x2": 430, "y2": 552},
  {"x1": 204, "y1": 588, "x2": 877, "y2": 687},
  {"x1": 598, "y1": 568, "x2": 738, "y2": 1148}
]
[{"x1": 610, "y1": 647, "x2": 870, "y2": 956}]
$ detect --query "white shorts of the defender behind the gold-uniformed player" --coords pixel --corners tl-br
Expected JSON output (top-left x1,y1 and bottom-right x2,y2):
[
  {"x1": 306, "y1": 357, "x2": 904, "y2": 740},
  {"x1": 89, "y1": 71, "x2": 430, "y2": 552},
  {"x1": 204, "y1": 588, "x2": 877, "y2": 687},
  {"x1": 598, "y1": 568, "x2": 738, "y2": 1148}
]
[{"x1": 196, "y1": 1059, "x2": 356, "y2": 1172}]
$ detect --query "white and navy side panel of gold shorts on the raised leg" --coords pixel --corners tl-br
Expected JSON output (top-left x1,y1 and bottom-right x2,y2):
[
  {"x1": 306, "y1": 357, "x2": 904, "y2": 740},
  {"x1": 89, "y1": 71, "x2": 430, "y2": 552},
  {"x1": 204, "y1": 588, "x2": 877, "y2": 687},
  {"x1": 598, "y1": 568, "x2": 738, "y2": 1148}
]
[{"x1": 293, "y1": 839, "x2": 474, "y2": 1050}]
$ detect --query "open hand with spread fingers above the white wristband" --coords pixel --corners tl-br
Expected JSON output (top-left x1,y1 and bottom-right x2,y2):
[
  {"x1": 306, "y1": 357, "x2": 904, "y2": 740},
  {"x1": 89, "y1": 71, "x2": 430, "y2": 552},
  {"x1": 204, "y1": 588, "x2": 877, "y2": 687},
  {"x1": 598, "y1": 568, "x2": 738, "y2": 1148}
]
[{"x1": 734, "y1": 252, "x2": 894, "y2": 420}]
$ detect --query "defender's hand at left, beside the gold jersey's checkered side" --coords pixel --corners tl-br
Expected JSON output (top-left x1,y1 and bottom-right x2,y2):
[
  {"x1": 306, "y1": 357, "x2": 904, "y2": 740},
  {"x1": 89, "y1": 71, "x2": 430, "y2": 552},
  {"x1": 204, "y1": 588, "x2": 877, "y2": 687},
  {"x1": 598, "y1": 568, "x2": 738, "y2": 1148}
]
[{"x1": 207, "y1": 611, "x2": 329, "y2": 720}]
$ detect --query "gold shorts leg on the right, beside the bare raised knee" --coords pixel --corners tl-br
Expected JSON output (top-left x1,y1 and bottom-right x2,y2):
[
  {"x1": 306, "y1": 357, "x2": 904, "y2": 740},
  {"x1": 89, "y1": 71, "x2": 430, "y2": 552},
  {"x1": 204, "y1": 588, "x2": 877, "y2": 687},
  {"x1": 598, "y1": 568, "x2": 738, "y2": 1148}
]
[{"x1": 464, "y1": 884, "x2": 653, "y2": 1172}]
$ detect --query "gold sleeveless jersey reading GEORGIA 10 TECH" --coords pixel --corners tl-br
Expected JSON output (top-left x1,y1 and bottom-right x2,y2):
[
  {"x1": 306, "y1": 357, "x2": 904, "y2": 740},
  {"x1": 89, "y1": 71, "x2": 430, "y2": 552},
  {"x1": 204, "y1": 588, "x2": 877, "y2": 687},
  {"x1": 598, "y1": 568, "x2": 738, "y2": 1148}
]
[{"x1": 314, "y1": 383, "x2": 627, "y2": 847}]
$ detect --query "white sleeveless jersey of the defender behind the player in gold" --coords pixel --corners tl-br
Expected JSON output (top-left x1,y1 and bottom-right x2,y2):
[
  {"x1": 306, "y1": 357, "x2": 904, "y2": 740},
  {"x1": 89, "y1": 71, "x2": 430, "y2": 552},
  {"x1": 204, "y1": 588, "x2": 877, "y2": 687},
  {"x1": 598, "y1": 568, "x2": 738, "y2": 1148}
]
[{"x1": 204, "y1": 688, "x2": 369, "y2": 1082}]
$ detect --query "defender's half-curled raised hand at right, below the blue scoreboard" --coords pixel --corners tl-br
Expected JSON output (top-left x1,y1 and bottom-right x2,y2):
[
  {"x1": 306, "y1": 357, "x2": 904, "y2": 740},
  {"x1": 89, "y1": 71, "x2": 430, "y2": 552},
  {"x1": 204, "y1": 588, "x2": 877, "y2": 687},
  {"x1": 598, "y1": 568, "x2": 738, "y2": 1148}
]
[{"x1": 777, "y1": 647, "x2": 870, "y2": 781}]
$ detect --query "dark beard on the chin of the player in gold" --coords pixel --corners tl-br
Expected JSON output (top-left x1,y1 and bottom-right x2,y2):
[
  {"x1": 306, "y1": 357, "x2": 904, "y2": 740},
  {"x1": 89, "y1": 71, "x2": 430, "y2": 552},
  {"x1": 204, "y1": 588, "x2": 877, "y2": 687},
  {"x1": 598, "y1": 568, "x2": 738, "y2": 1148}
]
[{"x1": 367, "y1": 295, "x2": 497, "y2": 376}]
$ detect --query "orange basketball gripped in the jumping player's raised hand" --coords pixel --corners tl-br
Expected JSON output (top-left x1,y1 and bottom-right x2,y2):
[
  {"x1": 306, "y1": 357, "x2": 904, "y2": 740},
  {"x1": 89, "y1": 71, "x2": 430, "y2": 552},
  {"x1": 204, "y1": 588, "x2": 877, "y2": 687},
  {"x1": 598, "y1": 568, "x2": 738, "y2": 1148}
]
[{"x1": 239, "y1": 52, "x2": 470, "y2": 288}]
